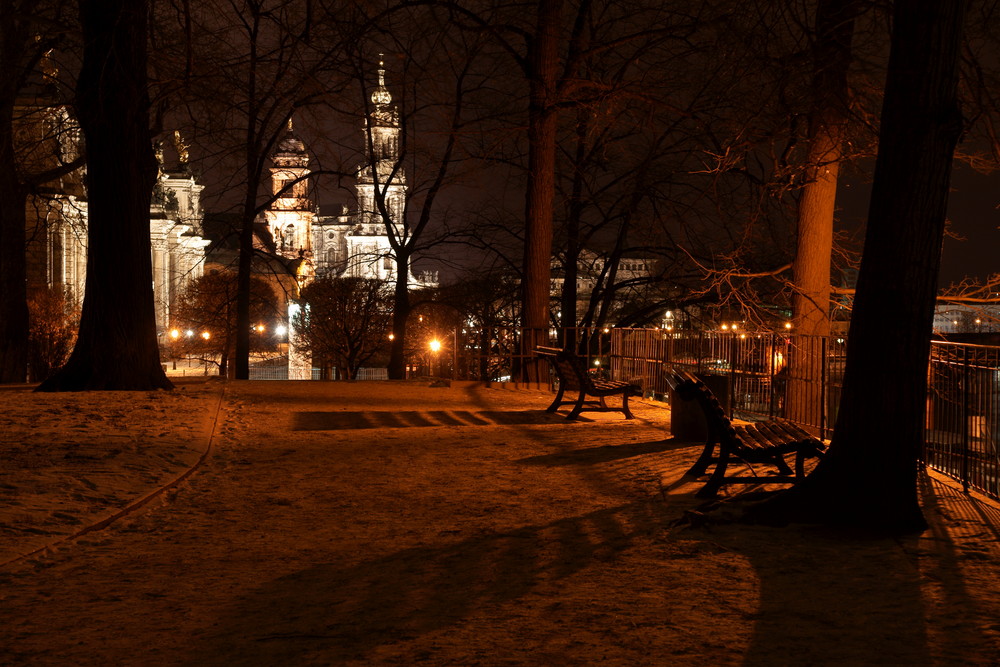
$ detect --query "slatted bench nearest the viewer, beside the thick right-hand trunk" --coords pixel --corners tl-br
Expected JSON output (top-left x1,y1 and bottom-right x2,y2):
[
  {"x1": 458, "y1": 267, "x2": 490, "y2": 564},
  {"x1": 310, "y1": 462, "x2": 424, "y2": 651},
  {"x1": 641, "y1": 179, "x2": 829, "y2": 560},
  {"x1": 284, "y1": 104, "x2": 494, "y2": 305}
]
[{"x1": 666, "y1": 369, "x2": 825, "y2": 498}]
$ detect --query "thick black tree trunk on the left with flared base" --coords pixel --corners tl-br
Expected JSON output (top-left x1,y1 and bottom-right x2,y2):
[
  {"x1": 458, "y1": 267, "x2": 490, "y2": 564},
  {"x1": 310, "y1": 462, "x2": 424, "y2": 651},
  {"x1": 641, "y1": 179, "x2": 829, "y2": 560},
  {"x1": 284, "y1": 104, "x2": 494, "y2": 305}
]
[{"x1": 39, "y1": 0, "x2": 173, "y2": 391}]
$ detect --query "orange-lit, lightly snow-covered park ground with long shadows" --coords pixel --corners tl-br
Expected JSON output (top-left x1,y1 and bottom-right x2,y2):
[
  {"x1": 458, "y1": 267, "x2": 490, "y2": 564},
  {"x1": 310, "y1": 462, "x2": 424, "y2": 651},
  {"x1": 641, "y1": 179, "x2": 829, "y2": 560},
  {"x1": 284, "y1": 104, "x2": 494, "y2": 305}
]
[{"x1": 0, "y1": 379, "x2": 1000, "y2": 665}]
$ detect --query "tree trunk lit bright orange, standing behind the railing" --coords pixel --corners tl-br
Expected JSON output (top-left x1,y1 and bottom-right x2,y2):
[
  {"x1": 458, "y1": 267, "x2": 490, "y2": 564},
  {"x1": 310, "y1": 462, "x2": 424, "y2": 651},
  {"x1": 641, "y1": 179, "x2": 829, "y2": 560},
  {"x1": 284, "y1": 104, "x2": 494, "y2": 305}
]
[{"x1": 785, "y1": 0, "x2": 857, "y2": 424}]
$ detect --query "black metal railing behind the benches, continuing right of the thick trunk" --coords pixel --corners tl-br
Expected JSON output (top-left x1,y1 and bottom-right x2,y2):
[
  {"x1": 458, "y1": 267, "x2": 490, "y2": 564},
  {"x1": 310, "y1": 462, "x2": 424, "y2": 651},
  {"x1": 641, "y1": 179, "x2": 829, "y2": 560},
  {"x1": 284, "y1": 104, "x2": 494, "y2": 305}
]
[{"x1": 610, "y1": 329, "x2": 1000, "y2": 498}]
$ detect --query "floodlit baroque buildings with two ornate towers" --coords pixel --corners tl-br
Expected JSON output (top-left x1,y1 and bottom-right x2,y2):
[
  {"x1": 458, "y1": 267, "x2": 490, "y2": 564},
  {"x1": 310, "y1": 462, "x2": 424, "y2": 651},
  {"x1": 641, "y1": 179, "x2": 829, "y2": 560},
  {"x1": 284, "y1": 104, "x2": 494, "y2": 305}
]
[{"x1": 258, "y1": 62, "x2": 438, "y2": 289}]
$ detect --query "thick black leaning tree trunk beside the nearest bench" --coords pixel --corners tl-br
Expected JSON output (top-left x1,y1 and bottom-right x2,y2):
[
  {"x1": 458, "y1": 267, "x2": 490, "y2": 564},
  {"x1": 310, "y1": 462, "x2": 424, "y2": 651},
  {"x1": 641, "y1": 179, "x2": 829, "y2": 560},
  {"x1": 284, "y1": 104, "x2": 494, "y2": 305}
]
[{"x1": 762, "y1": 0, "x2": 964, "y2": 533}]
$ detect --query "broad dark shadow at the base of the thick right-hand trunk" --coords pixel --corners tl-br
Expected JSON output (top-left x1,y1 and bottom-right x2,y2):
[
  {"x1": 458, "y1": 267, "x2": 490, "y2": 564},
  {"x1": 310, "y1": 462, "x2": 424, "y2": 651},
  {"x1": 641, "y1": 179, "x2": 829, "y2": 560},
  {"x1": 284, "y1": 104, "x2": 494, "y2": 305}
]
[{"x1": 711, "y1": 524, "x2": 929, "y2": 665}]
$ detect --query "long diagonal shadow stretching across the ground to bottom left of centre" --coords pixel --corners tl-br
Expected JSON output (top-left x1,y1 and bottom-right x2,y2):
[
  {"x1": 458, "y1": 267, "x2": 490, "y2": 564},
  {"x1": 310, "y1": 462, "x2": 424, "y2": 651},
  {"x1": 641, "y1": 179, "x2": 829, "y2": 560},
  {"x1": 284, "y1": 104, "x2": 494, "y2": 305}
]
[{"x1": 183, "y1": 502, "x2": 676, "y2": 664}]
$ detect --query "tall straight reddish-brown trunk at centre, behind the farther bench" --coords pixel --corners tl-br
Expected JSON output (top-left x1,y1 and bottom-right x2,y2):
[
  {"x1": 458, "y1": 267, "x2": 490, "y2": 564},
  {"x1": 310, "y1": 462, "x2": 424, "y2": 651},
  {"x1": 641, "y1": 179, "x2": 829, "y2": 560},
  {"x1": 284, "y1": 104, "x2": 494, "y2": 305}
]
[{"x1": 521, "y1": 0, "x2": 562, "y2": 382}]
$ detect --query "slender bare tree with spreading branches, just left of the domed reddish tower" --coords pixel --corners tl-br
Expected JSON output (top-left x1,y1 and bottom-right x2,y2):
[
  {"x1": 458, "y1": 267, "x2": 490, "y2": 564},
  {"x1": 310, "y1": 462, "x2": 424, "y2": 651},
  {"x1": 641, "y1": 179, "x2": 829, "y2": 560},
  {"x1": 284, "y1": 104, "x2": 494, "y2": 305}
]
[{"x1": 166, "y1": 0, "x2": 367, "y2": 379}]
